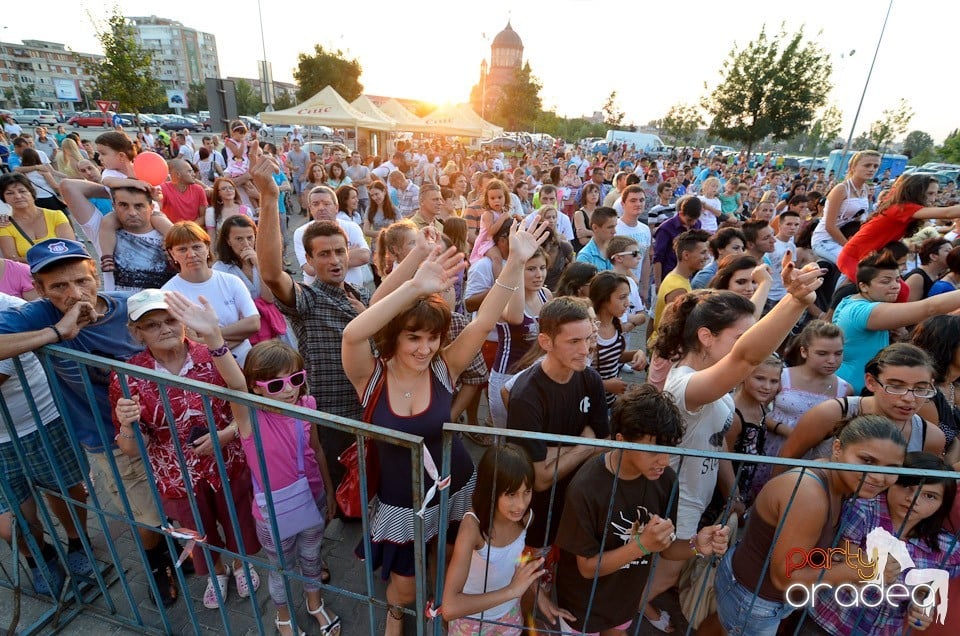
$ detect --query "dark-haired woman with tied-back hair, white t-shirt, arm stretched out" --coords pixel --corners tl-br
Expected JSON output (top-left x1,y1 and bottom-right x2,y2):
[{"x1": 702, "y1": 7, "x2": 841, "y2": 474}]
[{"x1": 645, "y1": 253, "x2": 822, "y2": 631}]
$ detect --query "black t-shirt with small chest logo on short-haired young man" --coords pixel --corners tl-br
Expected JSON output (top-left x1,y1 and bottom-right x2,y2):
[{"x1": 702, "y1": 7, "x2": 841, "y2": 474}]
[{"x1": 507, "y1": 363, "x2": 610, "y2": 547}]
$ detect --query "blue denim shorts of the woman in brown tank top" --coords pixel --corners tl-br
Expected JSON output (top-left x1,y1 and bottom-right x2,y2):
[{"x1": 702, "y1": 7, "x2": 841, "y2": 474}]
[{"x1": 714, "y1": 550, "x2": 794, "y2": 636}]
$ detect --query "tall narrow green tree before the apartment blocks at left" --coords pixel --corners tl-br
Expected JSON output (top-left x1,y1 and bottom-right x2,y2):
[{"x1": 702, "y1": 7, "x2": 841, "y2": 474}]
[{"x1": 84, "y1": 10, "x2": 165, "y2": 113}]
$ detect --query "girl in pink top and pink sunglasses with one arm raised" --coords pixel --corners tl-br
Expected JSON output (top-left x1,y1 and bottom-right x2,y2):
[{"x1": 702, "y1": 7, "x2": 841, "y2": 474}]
[{"x1": 167, "y1": 292, "x2": 340, "y2": 636}]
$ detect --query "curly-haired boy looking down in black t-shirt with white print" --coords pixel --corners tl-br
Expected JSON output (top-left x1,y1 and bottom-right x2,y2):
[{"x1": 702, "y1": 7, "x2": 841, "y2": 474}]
[{"x1": 555, "y1": 384, "x2": 730, "y2": 636}]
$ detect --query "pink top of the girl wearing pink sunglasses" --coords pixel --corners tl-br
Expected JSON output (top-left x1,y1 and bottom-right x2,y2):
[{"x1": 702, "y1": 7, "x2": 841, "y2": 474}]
[{"x1": 240, "y1": 395, "x2": 324, "y2": 520}]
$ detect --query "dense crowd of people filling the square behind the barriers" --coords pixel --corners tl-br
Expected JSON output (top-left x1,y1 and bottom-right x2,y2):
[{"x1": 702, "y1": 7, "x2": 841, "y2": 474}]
[{"x1": 0, "y1": 121, "x2": 960, "y2": 636}]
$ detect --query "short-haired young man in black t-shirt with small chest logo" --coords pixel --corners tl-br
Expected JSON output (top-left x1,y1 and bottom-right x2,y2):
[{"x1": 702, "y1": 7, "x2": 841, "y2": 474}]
[{"x1": 507, "y1": 297, "x2": 609, "y2": 552}]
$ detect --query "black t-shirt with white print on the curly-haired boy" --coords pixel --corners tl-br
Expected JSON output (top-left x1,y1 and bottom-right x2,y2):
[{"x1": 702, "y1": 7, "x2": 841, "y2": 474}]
[{"x1": 556, "y1": 455, "x2": 677, "y2": 632}]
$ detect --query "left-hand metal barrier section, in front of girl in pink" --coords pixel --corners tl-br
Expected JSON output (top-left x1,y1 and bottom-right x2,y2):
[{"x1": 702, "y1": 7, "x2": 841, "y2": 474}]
[{"x1": 0, "y1": 347, "x2": 427, "y2": 634}]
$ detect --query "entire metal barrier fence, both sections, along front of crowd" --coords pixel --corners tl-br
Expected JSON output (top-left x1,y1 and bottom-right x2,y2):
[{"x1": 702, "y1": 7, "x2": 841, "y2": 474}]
[{"x1": 0, "y1": 347, "x2": 957, "y2": 635}]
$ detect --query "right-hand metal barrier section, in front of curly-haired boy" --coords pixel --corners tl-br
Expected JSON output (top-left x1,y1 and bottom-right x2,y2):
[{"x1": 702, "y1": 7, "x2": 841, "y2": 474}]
[{"x1": 433, "y1": 424, "x2": 960, "y2": 636}]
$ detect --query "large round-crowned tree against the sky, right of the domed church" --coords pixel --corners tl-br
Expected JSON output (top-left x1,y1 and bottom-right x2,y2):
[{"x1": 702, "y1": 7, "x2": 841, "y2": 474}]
[{"x1": 703, "y1": 27, "x2": 833, "y2": 151}]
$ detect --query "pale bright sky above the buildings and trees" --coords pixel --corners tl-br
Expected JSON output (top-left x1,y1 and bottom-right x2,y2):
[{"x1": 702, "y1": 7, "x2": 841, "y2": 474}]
[{"x1": 0, "y1": 0, "x2": 960, "y2": 143}]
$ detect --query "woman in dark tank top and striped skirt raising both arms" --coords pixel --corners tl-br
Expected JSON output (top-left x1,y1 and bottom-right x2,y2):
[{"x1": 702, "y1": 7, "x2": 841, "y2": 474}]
[{"x1": 342, "y1": 223, "x2": 546, "y2": 636}]
